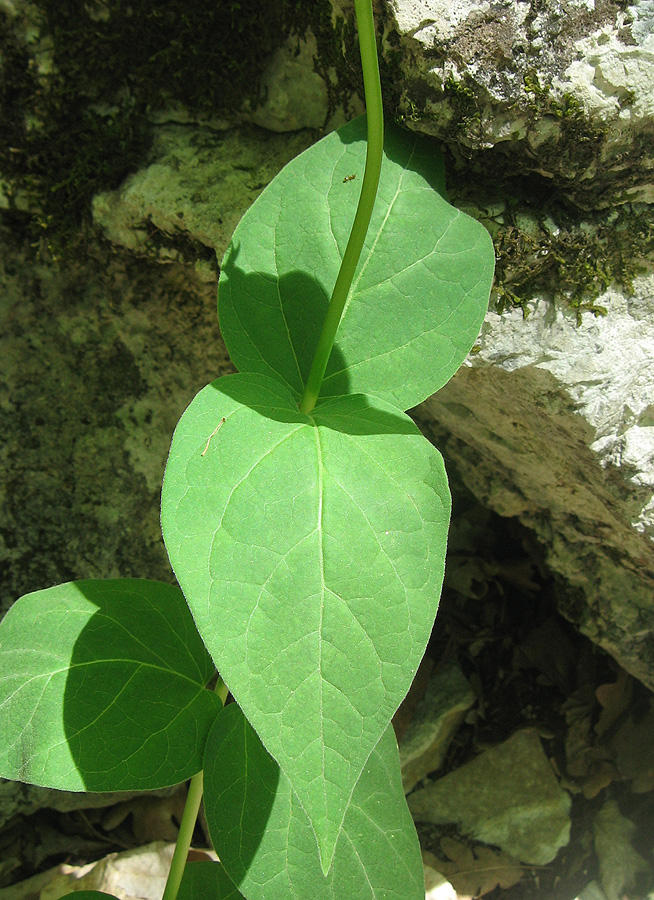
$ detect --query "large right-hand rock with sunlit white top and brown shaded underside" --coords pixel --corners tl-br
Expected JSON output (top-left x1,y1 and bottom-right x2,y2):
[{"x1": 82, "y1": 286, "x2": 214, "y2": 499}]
[{"x1": 419, "y1": 276, "x2": 654, "y2": 688}]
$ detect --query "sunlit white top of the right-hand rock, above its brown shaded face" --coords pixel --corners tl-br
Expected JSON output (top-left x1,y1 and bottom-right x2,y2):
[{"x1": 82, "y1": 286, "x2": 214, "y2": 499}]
[{"x1": 476, "y1": 275, "x2": 654, "y2": 540}]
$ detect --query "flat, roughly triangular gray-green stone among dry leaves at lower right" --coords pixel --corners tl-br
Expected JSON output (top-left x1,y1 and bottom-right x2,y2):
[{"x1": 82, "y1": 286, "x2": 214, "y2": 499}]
[{"x1": 408, "y1": 731, "x2": 570, "y2": 865}]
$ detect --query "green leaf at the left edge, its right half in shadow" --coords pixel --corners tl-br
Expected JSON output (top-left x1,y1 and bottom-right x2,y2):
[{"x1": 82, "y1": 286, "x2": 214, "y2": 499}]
[{"x1": 0, "y1": 579, "x2": 221, "y2": 791}]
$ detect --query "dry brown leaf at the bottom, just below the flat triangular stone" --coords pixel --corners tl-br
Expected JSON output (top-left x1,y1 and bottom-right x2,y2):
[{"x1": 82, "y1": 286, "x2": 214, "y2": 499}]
[{"x1": 438, "y1": 838, "x2": 523, "y2": 897}]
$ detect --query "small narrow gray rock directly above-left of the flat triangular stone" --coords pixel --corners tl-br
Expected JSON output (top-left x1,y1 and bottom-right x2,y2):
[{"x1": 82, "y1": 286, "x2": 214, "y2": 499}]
[{"x1": 400, "y1": 661, "x2": 475, "y2": 793}]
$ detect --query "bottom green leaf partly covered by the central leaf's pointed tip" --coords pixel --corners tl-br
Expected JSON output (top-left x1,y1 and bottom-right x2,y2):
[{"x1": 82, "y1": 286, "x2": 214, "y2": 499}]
[{"x1": 204, "y1": 703, "x2": 425, "y2": 900}]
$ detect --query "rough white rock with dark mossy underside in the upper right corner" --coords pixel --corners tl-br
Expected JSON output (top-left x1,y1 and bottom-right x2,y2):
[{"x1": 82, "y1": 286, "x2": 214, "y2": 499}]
[{"x1": 376, "y1": 0, "x2": 654, "y2": 207}]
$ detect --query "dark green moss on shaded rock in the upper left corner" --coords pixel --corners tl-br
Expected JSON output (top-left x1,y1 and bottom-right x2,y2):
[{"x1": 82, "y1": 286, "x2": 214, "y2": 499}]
[{"x1": 0, "y1": 0, "x2": 306, "y2": 252}]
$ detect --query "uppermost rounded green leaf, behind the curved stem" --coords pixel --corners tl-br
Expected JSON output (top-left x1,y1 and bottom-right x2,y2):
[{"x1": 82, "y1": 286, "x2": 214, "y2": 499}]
[{"x1": 218, "y1": 118, "x2": 495, "y2": 409}]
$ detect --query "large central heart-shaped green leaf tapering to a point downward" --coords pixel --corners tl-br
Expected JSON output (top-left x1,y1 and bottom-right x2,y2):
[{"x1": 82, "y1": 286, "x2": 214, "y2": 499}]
[{"x1": 162, "y1": 375, "x2": 450, "y2": 865}]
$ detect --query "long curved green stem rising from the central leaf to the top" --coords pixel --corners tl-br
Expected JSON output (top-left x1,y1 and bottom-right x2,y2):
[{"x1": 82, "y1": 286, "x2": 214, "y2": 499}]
[{"x1": 299, "y1": 0, "x2": 384, "y2": 413}]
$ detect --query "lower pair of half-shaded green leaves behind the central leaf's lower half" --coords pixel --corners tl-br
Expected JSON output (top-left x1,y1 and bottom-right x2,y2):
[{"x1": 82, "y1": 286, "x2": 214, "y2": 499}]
[{"x1": 0, "y1": 579, "x2": 424, "y2": 900}]
